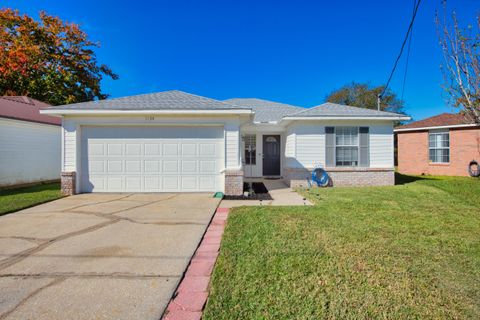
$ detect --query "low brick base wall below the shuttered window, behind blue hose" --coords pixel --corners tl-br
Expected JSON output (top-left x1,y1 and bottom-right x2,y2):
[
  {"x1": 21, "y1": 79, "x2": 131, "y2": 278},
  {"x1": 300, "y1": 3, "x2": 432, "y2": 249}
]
[{"x1": 283, "y1": 168, "x2": 395, "y2": 188}]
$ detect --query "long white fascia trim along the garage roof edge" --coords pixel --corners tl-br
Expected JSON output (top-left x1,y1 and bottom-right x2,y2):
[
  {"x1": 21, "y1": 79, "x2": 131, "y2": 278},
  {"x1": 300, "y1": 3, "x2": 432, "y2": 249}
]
[{"x1": 40, "y1": 109, "x2": 254, "y2": 116}]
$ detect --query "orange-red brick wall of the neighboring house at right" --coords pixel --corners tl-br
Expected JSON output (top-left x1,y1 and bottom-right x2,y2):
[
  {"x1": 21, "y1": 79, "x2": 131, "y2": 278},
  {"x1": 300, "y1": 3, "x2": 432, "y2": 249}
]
[{"x1": 397, "y1": 128, "x2": 480, "y2": 176}]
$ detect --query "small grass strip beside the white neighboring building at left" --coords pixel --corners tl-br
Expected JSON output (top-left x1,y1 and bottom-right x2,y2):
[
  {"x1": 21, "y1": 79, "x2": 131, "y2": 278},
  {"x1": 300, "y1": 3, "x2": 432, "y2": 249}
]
[{"x1": 0, "y1": 183, "x2": 62, "y2": 216}]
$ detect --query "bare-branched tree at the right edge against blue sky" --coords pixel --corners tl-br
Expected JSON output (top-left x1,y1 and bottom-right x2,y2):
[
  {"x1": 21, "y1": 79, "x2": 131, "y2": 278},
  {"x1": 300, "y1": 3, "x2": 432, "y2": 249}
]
[{"x1": 436, "y1": 7, "x2": 480, "y2": 124}]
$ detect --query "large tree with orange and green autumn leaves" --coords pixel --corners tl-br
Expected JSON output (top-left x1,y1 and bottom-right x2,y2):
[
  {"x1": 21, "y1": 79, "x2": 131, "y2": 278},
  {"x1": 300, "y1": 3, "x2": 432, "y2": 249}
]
[{"x1": 0, "y1": 8, "x2": 118, "y2": 105}]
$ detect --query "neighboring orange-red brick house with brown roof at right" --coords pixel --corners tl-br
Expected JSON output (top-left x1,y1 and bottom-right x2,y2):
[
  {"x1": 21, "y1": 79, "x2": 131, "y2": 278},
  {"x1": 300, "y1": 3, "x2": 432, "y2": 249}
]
[{"x1": 394, "y1": 113, "x2": 480, "y2": 176}]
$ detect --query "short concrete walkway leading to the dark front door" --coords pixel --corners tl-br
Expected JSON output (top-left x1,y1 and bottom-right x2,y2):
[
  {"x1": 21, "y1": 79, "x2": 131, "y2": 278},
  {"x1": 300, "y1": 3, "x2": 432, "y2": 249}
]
[{"x1": 220, "y1": 179, "x2": 312, "y2": 208}]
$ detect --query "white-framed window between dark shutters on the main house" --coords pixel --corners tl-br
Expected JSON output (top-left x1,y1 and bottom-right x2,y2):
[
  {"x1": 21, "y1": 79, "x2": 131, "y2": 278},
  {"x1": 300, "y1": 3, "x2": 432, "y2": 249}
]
[{"x1": 335, "y1": 127, "x2": 358, "y2": 167}]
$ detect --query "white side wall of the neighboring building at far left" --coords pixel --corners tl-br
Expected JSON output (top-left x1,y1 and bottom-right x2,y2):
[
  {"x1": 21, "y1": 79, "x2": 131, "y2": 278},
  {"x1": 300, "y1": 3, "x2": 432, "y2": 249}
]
[{"x1": 0, "y1": 118, "x2": 61, "y2": 186}]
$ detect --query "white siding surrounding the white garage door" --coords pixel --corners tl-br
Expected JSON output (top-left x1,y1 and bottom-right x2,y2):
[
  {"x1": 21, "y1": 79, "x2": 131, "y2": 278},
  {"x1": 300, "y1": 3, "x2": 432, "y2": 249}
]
[{"x1": 62, "y1": 116, "x2": 241, "y2": 190}]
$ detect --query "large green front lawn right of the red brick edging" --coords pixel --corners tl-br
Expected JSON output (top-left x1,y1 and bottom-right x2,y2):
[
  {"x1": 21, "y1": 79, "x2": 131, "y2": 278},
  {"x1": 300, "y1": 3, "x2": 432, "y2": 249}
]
[{"x1": 203, "y1": 175, "x2": 480, "y2": 319}]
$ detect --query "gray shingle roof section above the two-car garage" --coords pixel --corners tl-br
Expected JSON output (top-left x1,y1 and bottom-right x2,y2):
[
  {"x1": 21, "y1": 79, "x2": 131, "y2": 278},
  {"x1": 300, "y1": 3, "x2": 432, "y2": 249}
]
[{"x1": 49, "y1": 90, "x2": 249, "y2": 110}]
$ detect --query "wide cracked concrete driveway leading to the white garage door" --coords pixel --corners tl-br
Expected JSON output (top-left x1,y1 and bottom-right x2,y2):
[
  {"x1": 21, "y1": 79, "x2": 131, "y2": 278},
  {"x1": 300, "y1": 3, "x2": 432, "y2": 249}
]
[{"x1": 0, "y1": 194, "x2": 219, "y2": 320}]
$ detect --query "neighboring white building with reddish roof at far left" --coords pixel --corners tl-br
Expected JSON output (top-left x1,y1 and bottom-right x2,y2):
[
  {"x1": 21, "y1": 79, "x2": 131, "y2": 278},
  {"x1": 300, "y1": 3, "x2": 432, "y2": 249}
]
[{"x1": 0, "y1": 96, "x2": 62, "y2": 187}]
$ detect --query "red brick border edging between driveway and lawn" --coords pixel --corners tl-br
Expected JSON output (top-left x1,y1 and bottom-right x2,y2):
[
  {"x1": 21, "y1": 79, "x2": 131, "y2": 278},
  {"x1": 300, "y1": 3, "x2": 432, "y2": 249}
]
[{"x1": 163, "y1": 208, "x2": 229, "y2": 320}]
